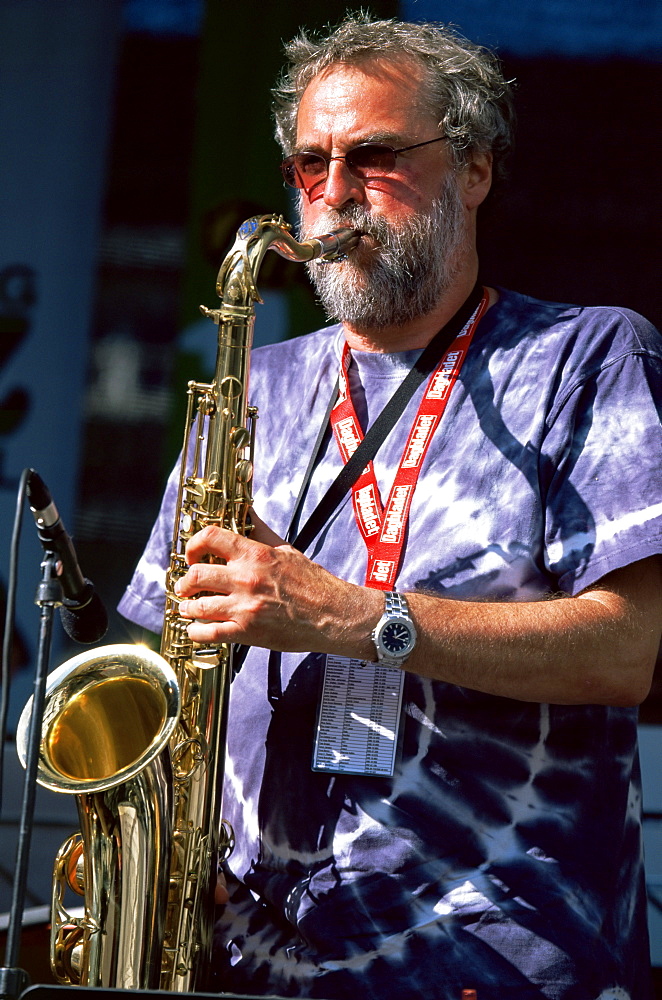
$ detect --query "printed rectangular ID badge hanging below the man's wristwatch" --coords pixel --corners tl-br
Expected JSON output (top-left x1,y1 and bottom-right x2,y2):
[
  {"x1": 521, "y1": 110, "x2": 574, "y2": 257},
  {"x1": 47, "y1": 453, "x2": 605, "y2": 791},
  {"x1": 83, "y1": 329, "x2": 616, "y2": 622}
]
[{"x1": 313, "y1": 654, "x2": 405, "y2": 777}]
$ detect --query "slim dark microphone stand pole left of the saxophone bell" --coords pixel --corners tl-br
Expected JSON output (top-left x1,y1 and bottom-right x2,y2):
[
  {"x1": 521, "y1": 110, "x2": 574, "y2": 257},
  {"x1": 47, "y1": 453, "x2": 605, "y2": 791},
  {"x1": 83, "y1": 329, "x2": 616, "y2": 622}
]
[{"x1": 0, "y1": 552, "x2": 63, "y2": 1000}]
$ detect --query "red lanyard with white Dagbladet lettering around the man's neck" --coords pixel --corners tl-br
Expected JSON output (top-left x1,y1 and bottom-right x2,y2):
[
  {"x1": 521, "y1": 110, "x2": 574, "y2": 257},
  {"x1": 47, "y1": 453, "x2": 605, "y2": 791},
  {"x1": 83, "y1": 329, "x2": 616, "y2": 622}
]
[{"x1": 331, "y1": 290, "x2": 488, "y2": 590}]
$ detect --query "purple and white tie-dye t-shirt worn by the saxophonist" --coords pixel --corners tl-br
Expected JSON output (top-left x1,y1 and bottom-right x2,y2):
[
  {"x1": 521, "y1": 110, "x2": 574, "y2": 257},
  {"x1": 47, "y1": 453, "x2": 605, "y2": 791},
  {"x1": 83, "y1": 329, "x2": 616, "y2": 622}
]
[{"x1": 120, "y1": 291, "x2": 662, "y2": 1000}]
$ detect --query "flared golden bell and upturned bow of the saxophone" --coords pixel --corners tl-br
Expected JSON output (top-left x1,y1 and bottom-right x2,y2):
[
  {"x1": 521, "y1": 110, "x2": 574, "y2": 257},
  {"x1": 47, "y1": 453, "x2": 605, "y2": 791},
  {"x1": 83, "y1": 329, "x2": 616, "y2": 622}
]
[{"x1": 16, "y1": 644, "x2": 181, "y2": 989}]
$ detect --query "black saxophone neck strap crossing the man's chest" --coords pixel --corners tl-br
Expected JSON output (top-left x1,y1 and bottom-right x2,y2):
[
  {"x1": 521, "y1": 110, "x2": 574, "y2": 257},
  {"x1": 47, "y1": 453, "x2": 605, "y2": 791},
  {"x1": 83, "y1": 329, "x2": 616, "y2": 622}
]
[{"x1": 286, "y1": 282, "x2": 483, "y2": 552}]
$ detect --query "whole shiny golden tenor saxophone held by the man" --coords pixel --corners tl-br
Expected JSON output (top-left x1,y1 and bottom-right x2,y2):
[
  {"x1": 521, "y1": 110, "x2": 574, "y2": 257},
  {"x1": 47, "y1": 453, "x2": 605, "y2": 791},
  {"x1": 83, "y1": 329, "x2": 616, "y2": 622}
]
[{"x1": 17, "y1": 215, "x2": 361, "y2": 993}]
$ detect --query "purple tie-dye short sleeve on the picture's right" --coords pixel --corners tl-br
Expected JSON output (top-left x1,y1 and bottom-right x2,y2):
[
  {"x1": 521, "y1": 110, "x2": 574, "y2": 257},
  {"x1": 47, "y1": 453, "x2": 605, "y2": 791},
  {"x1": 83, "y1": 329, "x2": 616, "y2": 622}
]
[{"x1": 540, "y1": 328, "x2": 662, "y2": 594}]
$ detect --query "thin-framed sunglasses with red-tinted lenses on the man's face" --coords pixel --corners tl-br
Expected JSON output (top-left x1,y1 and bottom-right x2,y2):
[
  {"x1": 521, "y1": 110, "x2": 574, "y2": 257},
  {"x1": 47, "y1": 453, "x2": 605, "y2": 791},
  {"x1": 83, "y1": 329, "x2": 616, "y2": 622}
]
[{"x1": 280, "y1": 135, "x2": 446, "y2": 190}]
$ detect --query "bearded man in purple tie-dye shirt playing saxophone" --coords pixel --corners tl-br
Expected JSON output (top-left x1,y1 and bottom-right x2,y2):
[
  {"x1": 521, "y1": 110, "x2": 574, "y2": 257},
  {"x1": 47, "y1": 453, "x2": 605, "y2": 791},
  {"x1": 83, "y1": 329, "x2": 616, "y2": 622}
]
[{"x1": 120, "y1": 17, "x2": 662, "y2": 1000}]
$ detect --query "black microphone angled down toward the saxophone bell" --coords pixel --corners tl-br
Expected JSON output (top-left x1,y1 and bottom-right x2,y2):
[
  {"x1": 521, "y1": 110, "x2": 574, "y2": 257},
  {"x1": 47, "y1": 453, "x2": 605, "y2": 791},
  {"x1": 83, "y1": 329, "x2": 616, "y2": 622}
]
[{"x1": 26, "y1": 469, "x2": 108, "y2": 643}]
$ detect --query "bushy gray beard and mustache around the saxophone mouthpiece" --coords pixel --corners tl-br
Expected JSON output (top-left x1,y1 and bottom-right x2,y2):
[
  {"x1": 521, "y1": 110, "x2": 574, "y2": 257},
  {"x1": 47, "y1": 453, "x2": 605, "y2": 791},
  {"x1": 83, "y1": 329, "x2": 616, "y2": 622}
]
[{"x1": 303, "y1": 177, "x2": 468, "y2": 329}]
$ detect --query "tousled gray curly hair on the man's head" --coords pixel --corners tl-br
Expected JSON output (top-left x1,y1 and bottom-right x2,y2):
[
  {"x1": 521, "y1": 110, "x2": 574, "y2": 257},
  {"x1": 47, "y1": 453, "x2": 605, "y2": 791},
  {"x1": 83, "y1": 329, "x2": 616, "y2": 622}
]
[{"x1": 273, "y1": 12, "x2": 515, "y2": 185}]
